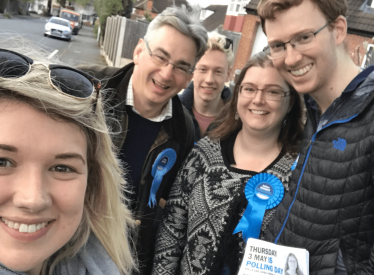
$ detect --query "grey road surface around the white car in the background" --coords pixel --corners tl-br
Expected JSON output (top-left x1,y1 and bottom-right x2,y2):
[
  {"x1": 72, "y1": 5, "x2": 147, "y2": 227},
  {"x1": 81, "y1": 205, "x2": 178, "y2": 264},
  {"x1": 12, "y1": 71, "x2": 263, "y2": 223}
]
[{"x1": 0, "y1": 15, "x2": 106, "y2": 66}]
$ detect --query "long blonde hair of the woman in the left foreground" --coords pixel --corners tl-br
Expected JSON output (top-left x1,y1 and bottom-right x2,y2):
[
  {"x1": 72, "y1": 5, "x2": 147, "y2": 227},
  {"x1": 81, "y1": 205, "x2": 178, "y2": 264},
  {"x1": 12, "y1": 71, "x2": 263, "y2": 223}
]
[{"x1": 0, "y1": 44, "x2": 136, "y2": 274}]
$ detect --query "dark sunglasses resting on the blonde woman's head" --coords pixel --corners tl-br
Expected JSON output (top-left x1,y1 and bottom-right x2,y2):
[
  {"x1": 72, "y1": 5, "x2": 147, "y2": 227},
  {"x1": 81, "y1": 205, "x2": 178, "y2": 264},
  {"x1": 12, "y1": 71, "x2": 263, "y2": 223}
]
[{"x1": 0, "y1": 49, "x2": 101, "y2": 110}]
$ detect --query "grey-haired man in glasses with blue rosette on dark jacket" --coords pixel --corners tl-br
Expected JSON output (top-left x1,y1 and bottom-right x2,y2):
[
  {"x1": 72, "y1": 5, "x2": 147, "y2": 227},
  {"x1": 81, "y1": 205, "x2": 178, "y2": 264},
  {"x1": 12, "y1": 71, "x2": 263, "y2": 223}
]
[{"x1": 81, "y1": 7, "x2": 208, "y2": 274}]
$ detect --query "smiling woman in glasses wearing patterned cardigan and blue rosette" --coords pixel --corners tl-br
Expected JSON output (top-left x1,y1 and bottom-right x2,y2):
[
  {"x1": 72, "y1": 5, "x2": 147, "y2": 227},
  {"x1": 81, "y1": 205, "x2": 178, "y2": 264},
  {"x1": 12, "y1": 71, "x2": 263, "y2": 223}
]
[{"x1": 153, "y1": 52, "x2": 303, "y2": 275}]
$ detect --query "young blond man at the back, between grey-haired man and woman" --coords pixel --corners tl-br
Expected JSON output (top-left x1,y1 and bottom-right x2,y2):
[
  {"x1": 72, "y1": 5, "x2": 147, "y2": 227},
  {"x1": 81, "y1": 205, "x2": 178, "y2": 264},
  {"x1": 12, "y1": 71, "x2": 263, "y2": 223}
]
[{"x1": 180, "y1": 32, "x2": 234, "y2": 141}]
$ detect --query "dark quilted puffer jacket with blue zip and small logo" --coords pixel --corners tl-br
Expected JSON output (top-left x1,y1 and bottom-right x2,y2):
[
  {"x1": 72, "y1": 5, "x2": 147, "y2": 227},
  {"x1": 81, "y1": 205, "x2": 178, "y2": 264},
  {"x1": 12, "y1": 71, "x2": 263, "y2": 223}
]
[{"x1": 266, "y1": 66, "x2": 374, "y2": 275}]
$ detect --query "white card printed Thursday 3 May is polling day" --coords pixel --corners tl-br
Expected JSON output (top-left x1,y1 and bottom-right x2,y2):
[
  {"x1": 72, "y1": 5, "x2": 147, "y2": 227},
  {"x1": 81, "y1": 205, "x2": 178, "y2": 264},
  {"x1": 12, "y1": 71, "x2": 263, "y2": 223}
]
[{"x1": 238, "y1": 239, "x2": 309, "y2": 275}]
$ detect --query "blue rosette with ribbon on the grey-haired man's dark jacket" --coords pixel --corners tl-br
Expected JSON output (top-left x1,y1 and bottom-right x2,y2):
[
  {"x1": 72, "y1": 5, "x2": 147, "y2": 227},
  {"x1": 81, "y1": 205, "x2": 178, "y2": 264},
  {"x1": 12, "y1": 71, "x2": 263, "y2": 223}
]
[{"x1": 148, "y1": 148, "x2": 177, "y2": 208}]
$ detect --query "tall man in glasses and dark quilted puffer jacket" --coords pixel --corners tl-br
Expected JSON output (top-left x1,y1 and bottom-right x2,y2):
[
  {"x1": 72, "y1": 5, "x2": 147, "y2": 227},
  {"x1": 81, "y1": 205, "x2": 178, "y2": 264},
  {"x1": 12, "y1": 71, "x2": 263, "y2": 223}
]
[{"x1": 258, "y1": 0, "x2": 374, "y2": 274}]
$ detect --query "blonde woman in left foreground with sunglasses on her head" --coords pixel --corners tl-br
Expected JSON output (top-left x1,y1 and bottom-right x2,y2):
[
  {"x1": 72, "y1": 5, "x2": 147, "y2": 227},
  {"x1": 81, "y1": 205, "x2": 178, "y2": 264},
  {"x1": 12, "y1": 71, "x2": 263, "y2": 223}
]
[{"x1": 0, "y1": 46, "x2": 135, "y2": 275}]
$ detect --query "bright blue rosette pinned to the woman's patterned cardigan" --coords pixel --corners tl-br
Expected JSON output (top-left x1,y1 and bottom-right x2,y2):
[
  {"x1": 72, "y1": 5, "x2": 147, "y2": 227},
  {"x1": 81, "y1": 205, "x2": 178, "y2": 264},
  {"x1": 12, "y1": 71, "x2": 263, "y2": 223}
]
[{"x1": 233, "y1": 173, "x2": 284, "y2": 242}]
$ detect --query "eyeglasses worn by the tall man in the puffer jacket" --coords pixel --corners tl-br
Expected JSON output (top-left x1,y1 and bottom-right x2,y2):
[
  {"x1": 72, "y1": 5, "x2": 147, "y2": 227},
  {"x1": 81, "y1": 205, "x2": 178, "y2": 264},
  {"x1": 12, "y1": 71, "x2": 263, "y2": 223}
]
[{"x1": 263, "y1": 21, "x2": 331, "y2": 59}]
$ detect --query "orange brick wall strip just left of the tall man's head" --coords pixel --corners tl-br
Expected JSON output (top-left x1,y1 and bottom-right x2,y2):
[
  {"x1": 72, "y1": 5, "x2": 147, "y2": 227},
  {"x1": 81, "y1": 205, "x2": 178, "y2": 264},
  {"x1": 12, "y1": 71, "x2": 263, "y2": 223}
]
[{"x1": 231, "y1": 14, "x2": 260, "y2": 80}]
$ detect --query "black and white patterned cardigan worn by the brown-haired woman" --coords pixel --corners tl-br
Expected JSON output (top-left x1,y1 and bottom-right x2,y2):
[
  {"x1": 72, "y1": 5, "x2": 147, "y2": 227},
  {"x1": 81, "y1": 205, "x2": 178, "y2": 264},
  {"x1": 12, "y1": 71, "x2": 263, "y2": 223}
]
[{"x1": 152, "y1": 137, "x2": 294, "y2": 275}]
